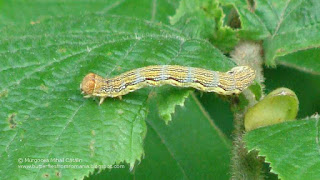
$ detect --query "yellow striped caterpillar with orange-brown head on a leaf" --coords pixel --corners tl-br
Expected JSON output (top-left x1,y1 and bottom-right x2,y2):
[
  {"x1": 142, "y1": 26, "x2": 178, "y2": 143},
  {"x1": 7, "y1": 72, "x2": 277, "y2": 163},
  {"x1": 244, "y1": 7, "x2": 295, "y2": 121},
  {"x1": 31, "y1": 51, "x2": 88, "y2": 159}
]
[{"x1": 80, "y1": 65, "x2": 255, "y2": 105}]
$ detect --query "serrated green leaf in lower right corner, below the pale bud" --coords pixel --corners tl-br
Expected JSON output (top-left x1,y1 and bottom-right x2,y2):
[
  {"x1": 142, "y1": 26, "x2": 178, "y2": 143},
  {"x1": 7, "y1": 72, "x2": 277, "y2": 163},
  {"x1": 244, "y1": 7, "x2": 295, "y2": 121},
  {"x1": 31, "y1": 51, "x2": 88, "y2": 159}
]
[{"x1": 245, "y1": 115, "x2": 320, "y2": 180}]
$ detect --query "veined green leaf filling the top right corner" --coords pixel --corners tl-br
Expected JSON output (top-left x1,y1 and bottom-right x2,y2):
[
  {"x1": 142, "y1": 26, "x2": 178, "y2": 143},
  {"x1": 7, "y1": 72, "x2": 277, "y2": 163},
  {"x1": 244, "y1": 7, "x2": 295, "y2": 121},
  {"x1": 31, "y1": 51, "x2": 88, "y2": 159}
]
[{"x1": 225, "y1": 0, "x2": 320, "y2": 73}]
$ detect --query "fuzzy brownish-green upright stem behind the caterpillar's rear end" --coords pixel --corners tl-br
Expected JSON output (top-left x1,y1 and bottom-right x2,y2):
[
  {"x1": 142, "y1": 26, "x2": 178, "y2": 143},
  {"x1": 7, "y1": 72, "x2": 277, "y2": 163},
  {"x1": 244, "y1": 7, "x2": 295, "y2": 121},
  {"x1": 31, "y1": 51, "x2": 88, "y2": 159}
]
[{"x1": 231, "y1": 41, "x2": 265, "y2": 179}]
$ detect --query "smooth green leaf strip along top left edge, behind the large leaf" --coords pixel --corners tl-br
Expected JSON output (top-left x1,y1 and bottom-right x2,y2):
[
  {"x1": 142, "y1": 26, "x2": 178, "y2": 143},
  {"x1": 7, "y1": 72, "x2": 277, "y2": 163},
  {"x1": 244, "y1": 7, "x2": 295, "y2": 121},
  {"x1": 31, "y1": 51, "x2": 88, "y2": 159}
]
[{"x1": 0, "y1": 0, "x2": 178, "y2": 28}]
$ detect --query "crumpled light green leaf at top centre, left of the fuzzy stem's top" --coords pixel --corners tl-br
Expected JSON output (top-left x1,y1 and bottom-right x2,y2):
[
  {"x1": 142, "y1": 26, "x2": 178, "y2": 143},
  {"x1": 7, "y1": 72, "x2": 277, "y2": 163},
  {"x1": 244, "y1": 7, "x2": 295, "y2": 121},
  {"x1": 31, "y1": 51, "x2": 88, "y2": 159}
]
[{"x1": 170, "y1": 0, "x2": 238, "y2": 51}]
